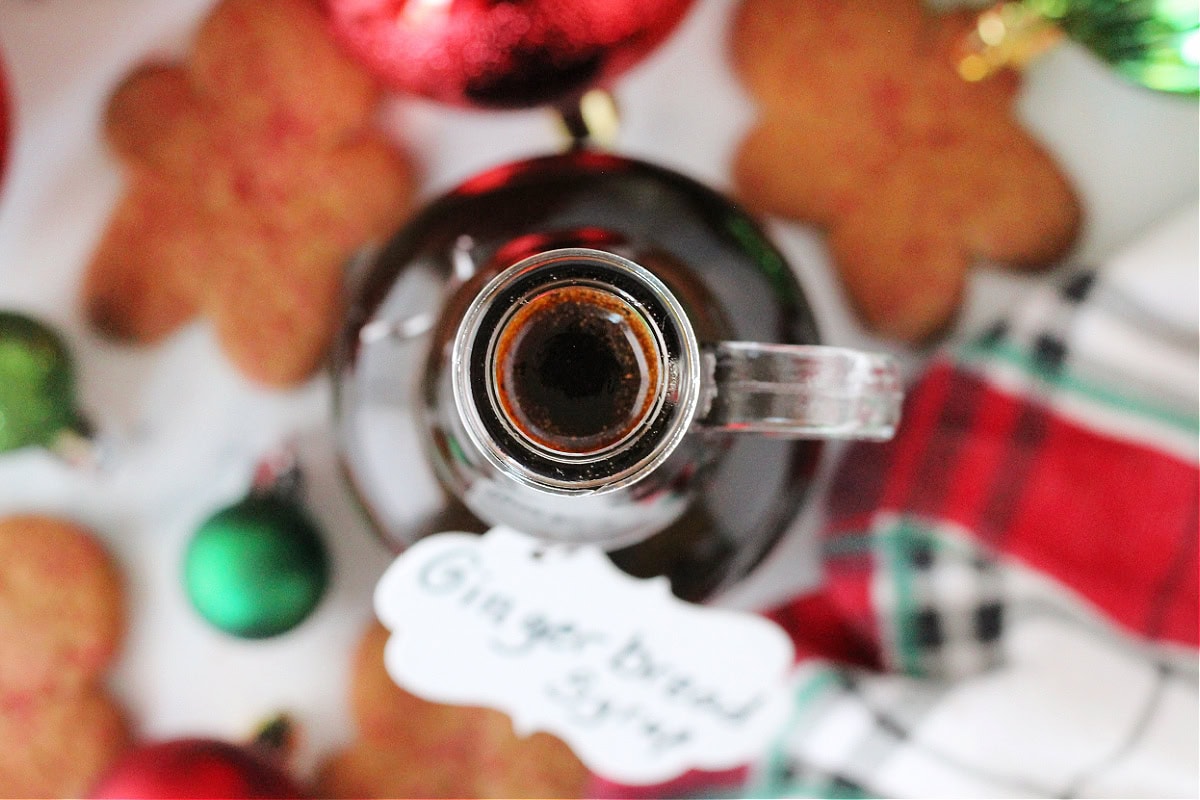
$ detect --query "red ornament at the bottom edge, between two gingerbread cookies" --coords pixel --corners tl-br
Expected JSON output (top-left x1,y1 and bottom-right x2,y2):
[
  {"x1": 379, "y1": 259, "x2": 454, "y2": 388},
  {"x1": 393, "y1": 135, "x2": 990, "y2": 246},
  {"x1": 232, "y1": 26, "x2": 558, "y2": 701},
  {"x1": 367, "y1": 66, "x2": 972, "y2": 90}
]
[{"x1": 91, "y1": 739, "x2": 307, "y2": 800}]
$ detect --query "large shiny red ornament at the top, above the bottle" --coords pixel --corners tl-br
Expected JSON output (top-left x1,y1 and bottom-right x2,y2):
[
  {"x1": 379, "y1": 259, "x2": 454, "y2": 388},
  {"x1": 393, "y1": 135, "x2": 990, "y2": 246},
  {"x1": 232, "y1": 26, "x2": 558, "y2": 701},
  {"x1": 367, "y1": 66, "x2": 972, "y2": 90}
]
[{"x1": 325, "y1": 0, "x2": 692, "y2": 108}]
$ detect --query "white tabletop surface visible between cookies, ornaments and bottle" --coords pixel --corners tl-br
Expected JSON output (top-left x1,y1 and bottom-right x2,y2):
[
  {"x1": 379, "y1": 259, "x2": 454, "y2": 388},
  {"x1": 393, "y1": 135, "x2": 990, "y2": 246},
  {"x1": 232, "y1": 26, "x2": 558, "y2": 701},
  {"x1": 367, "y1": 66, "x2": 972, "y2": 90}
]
[{"x1": 0, "y1": 0, "x2": 1198, "y2": 769}]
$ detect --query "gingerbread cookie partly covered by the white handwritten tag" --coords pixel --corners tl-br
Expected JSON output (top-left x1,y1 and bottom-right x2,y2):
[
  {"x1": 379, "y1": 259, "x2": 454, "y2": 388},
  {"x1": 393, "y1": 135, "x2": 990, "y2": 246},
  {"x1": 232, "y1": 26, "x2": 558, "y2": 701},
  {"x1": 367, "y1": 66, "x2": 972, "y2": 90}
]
[{"x1": 317, "y1": 624, "x2": 588, "y2": 798}]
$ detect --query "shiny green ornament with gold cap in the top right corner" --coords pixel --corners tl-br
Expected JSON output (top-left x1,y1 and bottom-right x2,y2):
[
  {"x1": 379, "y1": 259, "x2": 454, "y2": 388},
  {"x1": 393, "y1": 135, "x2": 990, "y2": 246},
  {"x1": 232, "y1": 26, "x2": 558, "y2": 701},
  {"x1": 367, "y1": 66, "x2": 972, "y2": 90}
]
[{"x1": 959, "y1": 0, "x2": 1200, "y2": 95}]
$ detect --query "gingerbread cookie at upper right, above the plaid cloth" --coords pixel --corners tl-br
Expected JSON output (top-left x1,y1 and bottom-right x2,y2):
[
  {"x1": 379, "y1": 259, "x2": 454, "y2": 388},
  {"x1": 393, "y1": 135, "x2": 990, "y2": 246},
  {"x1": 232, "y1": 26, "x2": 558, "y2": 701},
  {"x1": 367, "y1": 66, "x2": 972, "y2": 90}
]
[{"x1": 732, "y1": 0, "x2": 1080, "y2": 343}]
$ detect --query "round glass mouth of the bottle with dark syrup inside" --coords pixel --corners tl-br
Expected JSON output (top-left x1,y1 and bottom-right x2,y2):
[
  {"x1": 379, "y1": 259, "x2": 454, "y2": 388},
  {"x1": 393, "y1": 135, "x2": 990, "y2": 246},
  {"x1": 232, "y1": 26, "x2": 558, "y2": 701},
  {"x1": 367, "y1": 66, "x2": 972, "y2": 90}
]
[{"x1": 452, "y1": 248, "x2": 700, "y2": 494}]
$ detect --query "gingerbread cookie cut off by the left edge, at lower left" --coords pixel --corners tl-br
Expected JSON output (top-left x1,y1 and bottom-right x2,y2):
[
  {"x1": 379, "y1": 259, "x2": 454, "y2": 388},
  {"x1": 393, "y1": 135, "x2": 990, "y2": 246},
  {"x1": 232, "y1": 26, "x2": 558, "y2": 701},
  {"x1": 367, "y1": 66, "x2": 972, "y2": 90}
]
[{"x1": 0, "y1": 516, "x2": 130, "y2": 798}]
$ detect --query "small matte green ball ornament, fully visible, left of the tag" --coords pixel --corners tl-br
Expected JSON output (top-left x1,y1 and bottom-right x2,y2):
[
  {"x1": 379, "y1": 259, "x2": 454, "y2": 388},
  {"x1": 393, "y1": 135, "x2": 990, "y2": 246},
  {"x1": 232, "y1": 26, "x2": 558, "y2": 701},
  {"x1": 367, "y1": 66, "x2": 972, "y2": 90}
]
[{"x1": 184, "y1": 450, "x2": 329, "y2": 639}]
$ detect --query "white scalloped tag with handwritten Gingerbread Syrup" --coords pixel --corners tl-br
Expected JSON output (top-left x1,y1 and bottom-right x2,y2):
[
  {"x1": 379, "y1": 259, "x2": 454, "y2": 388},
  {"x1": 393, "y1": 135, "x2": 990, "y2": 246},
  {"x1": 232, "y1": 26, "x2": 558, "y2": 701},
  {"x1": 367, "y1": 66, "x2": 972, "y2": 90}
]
[{"x1": 374, "y1": 528, "x2": 793, "y2": 784}]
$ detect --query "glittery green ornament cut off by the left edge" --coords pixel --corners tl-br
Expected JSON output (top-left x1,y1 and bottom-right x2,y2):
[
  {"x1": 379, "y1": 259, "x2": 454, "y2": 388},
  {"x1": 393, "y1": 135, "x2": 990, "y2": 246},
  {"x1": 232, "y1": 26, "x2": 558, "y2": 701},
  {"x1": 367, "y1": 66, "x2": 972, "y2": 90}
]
[{"x1": 0, "y1": 311, "x2": 86, "y2": 453}]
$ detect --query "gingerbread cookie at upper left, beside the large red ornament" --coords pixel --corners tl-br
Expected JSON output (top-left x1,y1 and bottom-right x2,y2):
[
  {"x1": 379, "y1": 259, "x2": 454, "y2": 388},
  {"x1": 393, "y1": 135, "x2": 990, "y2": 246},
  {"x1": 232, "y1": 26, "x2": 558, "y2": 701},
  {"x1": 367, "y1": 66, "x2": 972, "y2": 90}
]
[{"x1": 83, "y1": 0, "x2": 413, "y2": 386}]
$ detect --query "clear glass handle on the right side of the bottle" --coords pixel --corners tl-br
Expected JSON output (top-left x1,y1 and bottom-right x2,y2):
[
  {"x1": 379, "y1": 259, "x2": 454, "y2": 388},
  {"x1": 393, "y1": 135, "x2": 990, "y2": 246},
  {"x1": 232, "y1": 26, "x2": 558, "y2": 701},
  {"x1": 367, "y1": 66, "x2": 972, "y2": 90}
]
[{"x1": 697, "y1": 342, "x2": 904, "y2": 440}]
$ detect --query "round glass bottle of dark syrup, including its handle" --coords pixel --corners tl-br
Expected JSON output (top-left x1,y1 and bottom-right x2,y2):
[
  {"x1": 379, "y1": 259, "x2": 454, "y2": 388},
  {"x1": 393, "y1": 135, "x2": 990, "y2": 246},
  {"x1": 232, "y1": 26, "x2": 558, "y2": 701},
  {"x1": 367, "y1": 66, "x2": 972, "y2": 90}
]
[{"x1": 335, "y1": 149, "x2": 900, "y2": 600}]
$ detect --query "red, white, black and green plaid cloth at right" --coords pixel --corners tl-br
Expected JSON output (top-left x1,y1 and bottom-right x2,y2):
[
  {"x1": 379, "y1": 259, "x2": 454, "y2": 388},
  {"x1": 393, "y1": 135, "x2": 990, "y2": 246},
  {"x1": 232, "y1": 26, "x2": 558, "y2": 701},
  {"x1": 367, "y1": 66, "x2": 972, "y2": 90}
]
[{"x1": 740, "y1": 207, "x2": 1200, "y2": 798}]
